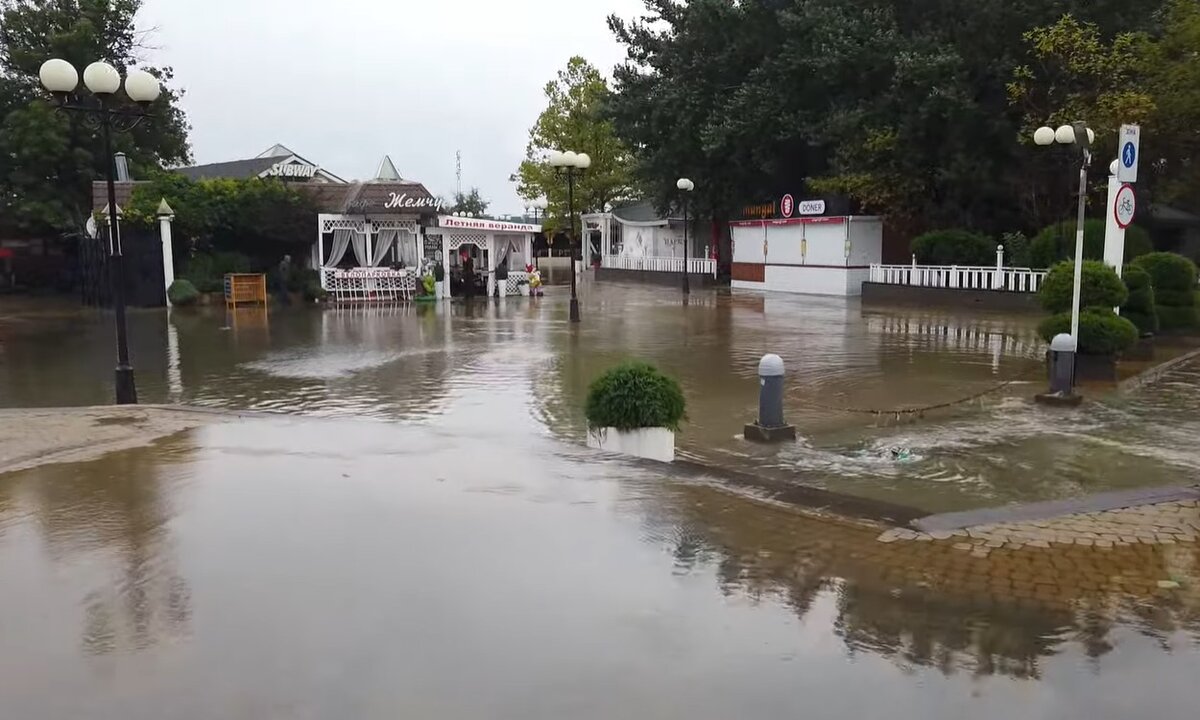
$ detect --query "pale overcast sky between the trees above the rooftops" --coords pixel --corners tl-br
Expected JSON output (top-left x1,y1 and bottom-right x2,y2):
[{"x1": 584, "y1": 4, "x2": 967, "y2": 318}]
[{"x1": 138, "y1": 0, "x2": 643, "y2": 214}]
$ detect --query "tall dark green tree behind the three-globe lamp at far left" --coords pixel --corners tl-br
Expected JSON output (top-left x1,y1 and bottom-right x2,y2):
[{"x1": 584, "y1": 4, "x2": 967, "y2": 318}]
[{"x1": 0, "y1": 0, "x2": 191, "y2": 234}]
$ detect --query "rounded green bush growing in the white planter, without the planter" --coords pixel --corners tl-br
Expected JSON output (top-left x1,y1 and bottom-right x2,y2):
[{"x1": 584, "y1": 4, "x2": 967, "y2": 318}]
[{"x1": 584, "y1": 360, "x2": 684, "y2": 430}]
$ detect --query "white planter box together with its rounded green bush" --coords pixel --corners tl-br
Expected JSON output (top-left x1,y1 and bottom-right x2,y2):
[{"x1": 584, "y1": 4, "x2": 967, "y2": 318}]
[{"x1": 584, "y1": 360, "x2": 686, "y2": 462}]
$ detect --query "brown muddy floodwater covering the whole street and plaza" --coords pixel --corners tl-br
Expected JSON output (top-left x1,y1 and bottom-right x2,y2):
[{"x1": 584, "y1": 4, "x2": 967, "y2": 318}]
[{"x1": 0, "y1": 287, "x2": 1200, "y2": 720}]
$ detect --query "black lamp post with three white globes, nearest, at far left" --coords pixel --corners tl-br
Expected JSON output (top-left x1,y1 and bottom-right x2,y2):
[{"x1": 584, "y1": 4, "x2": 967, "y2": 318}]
[{"x1": 38, "y1": 58, "x2": 162, "y2": 404}]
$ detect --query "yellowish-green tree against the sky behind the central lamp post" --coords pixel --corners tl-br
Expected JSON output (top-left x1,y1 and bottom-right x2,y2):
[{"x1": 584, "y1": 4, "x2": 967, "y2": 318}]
[{"x1": 512, "y1": 56, "x2": 632, "y2": 234}]
